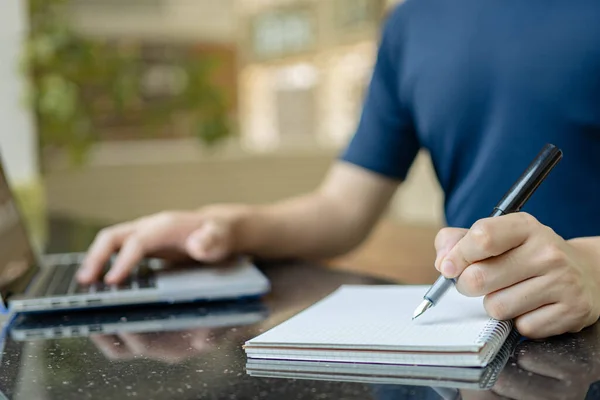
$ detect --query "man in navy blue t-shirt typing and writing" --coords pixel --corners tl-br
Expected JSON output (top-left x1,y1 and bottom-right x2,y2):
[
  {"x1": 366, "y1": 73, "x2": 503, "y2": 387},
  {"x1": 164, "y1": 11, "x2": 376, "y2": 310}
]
[{"x1": 79, "y1": 0, "x2": 600, "y2": 338}]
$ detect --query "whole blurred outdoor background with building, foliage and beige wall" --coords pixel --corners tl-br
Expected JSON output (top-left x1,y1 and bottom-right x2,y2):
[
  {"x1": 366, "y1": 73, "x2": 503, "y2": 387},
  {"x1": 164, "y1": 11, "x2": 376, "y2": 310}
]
[{"x1": 0, "y1": 0, "x2": 443, "y2": 280}]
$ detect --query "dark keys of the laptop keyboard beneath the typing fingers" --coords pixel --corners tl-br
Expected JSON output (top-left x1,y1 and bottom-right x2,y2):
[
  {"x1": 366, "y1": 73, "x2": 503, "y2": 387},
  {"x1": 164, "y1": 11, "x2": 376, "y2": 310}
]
[{"x1": 46, "y1": 263, "x2": 156, "y2": 296}]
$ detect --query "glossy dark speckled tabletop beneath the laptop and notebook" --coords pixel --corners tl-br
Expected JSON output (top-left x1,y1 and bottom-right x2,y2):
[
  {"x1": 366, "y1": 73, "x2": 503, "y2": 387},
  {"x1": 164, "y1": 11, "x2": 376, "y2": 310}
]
[{"x1": 0, "y1": 219, "x2": 600, "y2": 400}]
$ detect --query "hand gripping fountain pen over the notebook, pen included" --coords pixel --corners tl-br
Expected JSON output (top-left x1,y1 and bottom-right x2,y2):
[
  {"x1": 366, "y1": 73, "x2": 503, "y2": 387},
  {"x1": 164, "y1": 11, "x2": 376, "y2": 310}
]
[{"x1": 415, "y1": 145, "x2": 600, "y2": 338}]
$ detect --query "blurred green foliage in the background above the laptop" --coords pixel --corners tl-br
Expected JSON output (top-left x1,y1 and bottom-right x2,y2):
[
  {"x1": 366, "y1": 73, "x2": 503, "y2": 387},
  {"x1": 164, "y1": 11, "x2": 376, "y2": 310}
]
[{"x1": 23, "y1": 0, "x2": 232, "y2": 166}]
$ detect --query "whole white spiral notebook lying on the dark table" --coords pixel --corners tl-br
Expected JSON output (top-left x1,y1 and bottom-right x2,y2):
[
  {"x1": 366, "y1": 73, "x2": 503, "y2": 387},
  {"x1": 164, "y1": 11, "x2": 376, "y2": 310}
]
[{"x1": 244, "y1": 285, "x2": 513, "y2": 367}]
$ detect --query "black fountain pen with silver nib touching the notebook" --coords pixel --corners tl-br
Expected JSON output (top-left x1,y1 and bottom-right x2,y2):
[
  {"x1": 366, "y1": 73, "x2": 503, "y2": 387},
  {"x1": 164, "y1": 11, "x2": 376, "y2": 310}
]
[{"x1": 413, "y1": 144, "x2": 562, "y2": 319}]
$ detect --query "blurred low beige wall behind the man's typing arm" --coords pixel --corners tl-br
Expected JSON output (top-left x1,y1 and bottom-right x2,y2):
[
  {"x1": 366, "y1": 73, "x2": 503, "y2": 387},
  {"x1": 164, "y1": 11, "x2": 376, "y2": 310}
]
[{"x1": 45, "y1": 140, "x2": 443, "y2": 226}]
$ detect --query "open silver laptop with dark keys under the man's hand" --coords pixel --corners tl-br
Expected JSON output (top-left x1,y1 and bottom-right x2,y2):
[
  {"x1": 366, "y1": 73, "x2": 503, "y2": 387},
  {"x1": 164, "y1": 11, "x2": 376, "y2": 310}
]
[{"x1": 0, "y1": 160, "x2": 270, "y2": 313}]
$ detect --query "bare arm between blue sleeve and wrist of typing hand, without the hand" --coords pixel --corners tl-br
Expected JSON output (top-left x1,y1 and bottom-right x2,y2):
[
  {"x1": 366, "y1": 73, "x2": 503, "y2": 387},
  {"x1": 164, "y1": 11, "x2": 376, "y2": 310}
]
[{"x1": 239, "y1": 161, "x2": 398, "y2": 258}]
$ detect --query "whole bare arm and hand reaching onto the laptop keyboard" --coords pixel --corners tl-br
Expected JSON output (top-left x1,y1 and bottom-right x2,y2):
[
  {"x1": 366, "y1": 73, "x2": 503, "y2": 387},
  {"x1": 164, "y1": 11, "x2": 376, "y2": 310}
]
[{"x1": 78, "y1": 161, "x2": 397, "y2": 283}]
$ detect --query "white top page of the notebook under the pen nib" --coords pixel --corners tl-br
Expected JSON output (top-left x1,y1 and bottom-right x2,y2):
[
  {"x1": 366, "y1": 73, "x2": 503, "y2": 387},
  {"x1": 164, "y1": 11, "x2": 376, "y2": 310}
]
[{"x1": 246, "y1": 285, "x2": 495, "y2": 351}]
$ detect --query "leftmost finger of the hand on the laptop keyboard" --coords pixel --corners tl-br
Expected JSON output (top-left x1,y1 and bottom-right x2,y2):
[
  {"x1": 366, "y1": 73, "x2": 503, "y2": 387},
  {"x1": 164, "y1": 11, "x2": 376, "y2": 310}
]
[{"x1": 77, "y1": 223, "x2": 134, "y2": 285}]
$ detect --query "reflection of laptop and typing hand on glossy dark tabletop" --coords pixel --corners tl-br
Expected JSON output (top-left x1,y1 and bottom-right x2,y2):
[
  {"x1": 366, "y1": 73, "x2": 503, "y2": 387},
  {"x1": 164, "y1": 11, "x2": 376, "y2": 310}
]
[{"x1": 9, "y1": 300, "x2": 268, "y2": 363}]
